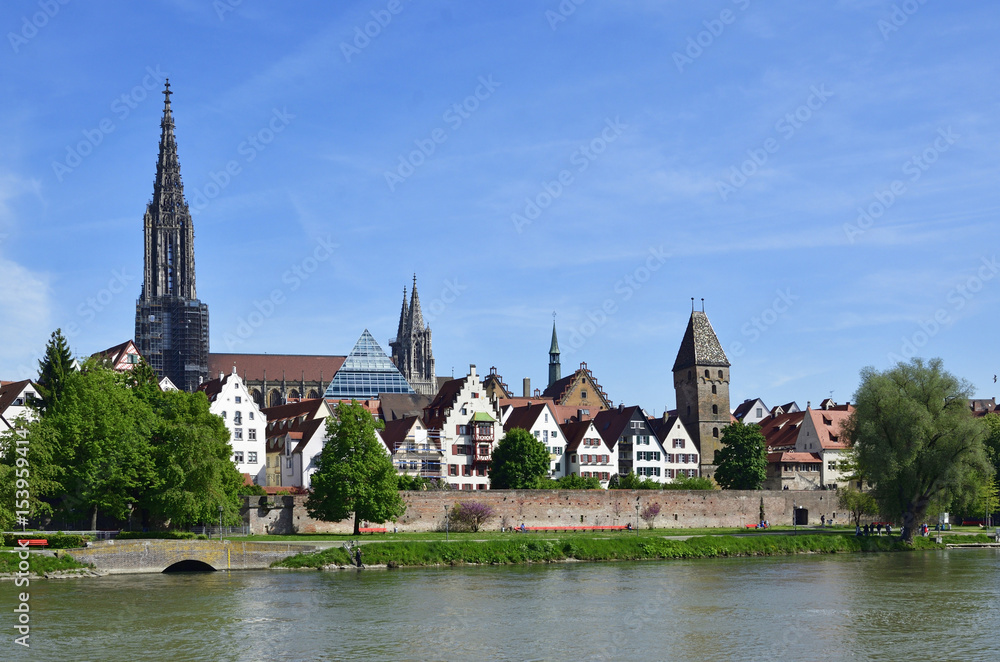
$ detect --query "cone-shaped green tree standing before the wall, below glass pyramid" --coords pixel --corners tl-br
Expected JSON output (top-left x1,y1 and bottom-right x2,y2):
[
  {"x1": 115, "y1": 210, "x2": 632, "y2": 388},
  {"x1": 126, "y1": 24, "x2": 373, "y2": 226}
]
[{"x1": 306, "y1": 400, "x2": 406, "y2": 535}]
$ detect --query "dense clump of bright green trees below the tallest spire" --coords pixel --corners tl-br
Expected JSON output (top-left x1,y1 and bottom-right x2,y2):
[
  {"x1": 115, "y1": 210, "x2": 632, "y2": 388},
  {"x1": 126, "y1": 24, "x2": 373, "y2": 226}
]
[{"x1": 0, "y1": 360, "x2": 243, "y2": 529}]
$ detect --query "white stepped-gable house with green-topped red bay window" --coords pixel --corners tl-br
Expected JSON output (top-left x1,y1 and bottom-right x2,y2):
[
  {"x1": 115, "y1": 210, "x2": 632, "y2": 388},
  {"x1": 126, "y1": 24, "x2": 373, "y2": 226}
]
[{"x1": 424, "y1": 365, "x2": 501, "y2": 490}]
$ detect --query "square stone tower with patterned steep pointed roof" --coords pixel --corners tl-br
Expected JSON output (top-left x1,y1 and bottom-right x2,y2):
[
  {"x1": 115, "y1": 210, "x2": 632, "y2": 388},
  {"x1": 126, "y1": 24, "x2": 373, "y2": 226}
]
[{"x1": 673, "y1": 310, "x2": 730, "y2": 476}]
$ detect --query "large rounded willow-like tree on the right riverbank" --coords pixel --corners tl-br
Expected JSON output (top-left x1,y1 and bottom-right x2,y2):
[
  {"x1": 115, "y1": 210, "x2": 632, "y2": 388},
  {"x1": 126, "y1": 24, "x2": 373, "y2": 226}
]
[{"x1": 844, "y1": 359, "x2": 992, "y2": 541}]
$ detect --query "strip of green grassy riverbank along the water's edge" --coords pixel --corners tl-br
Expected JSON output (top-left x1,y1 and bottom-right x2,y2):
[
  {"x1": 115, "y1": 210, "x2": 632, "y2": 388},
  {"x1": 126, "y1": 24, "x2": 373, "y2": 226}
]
[{"x1": 273, "y1": 535, "x2": 943, "y2": 568}]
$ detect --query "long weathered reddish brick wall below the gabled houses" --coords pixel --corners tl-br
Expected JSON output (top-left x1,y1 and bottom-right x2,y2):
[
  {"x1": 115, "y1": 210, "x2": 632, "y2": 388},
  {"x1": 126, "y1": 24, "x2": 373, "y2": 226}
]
[{"x1": 243, "y1": 490, "x2": 836, "y2": 534}]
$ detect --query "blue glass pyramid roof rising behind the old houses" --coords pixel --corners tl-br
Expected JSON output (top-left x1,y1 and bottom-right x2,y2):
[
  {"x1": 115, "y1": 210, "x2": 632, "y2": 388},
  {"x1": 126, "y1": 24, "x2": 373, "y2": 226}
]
[{"x1": 323, "y1": 329, "x2": 416, "y2": 400}]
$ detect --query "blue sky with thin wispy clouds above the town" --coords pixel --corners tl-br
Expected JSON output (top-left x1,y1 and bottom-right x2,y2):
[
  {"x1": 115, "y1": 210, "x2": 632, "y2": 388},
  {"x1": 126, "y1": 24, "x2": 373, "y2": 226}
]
[{"x1": 0, "y1": 0, "x2": 1000, "y2": 413}]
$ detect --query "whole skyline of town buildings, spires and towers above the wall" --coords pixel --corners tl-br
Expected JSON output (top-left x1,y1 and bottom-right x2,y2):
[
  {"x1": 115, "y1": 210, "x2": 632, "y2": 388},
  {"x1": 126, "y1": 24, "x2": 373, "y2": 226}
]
[{"x1": 25, "y1": 81, "x2": 984, "y2": 490}]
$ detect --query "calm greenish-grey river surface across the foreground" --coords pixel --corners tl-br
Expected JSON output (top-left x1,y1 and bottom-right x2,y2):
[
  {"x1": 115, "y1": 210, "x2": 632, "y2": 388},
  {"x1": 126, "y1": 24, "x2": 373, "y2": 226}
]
[{"x1": 0, "y1": 549, "x2": 1000, "y2": 661}]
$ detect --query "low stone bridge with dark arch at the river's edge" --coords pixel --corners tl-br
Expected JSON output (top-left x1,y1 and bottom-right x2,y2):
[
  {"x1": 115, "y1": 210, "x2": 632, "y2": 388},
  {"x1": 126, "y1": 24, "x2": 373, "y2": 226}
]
[{"x1": 66, "y1": 540, "x2": 315, "y2": 574}]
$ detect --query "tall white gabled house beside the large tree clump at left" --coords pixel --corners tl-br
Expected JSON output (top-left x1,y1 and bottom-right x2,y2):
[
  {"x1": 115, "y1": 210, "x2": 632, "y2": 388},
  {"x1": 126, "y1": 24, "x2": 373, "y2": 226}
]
[{"x1": 198, "y1": 368, "x2": 267, "y2": 485}]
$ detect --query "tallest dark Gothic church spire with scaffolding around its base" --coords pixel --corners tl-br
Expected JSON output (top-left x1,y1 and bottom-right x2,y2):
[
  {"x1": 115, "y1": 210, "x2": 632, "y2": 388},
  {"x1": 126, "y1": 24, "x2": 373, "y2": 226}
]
[{"x1": 135, "y1": 80, "x2": 208, "y2": 391}]
